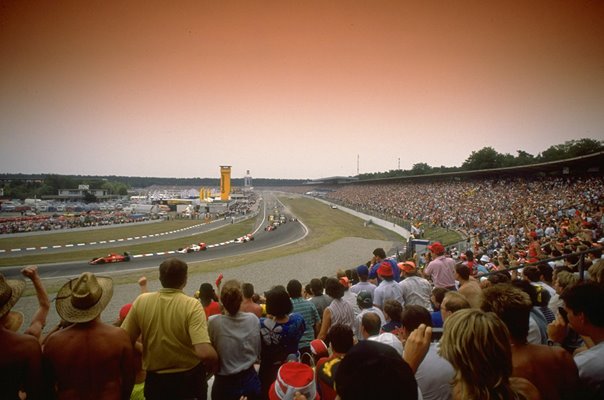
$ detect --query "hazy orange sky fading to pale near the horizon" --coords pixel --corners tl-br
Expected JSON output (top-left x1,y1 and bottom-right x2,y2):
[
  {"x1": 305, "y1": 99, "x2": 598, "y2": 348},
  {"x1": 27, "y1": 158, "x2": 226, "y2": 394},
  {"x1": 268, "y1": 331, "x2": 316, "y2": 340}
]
[{"x1": 0, "y1": 0, "x2": 604, "y2": 179}]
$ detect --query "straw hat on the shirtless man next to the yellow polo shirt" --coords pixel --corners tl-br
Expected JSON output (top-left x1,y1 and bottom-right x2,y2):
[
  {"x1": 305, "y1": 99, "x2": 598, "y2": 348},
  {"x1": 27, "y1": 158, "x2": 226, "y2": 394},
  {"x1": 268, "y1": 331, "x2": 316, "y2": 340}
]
[{"x1": 56, "y1": 272, "x2": 113, "y2": 323}]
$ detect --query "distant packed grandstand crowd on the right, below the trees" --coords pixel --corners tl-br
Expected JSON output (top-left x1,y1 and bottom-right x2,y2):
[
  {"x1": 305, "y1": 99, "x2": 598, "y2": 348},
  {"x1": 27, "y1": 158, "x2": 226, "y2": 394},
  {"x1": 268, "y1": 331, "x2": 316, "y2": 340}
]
[{"x1": 327, "y1": 176, "x2": 604, "y2": 249}]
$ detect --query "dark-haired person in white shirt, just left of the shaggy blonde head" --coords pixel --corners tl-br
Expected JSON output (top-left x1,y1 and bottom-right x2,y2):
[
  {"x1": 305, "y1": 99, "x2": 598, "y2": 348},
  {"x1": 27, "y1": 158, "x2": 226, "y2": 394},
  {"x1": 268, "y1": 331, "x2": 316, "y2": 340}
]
[{"x1": 401, "y1": 304, "x2": 455, "y2": 400}]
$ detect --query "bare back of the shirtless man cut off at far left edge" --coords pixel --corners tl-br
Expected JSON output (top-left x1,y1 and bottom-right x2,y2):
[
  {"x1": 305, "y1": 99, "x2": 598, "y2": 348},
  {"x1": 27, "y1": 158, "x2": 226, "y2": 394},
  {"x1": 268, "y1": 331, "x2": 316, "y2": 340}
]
[{"x1": 0, "y1": 327, "x2": 42, "y2": 399}]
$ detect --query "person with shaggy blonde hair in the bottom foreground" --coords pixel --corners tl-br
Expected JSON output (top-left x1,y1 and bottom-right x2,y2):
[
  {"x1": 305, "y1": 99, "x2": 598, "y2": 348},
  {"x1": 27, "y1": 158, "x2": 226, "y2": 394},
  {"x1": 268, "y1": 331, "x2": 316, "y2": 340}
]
[{"x1": 440, "y1": 309, "x2": 541, "y2": 400}]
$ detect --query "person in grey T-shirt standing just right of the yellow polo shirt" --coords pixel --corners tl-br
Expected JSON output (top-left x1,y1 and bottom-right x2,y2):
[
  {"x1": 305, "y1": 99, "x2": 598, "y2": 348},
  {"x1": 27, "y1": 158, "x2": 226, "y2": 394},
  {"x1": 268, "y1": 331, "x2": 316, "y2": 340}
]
[{"x1": 208, "y1": 280, "x2": 261, "y2": 400}]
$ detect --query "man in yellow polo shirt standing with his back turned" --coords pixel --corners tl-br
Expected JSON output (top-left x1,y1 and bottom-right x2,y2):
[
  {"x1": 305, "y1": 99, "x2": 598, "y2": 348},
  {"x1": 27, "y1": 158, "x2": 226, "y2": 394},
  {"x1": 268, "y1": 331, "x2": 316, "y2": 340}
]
[{"x1": 122, "y1": 258, "x2": 218, "y2": 400}]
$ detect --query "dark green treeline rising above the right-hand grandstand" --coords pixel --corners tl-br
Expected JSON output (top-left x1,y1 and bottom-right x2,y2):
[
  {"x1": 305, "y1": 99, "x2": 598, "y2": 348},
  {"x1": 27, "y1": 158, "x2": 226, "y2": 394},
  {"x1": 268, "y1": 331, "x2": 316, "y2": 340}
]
[{"x1": 359, "y1": 139, "x2": 604, "y2": 180}]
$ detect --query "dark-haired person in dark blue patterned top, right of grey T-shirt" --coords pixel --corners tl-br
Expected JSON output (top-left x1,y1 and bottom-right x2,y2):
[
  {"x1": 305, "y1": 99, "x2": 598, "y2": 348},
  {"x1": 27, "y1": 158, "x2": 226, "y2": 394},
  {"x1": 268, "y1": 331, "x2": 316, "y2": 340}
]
[{"x1": 258, "y1": 283, "x2": 306, "y2": 398}]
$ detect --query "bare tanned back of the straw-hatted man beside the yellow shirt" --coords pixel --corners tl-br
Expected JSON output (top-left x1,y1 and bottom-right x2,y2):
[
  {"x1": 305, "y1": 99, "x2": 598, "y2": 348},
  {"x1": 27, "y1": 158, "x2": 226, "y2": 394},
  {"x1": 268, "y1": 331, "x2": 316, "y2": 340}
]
[{"x1": 44, "y1": 318, "x2": 136, "y2": 400}]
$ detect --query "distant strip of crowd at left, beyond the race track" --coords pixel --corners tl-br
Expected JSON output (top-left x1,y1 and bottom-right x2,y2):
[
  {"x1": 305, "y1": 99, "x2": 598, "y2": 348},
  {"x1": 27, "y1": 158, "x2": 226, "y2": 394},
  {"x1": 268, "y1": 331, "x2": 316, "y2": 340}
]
[{"x1": 0, "y1": 212, "x2": 157, "y2": 235}]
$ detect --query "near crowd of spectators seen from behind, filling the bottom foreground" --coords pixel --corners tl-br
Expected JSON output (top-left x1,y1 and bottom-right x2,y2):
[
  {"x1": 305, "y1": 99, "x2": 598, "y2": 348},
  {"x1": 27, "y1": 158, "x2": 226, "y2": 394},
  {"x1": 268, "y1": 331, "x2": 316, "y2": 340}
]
[{"x1": 0, "y1": 234, "x2": 604, "y2": 400}]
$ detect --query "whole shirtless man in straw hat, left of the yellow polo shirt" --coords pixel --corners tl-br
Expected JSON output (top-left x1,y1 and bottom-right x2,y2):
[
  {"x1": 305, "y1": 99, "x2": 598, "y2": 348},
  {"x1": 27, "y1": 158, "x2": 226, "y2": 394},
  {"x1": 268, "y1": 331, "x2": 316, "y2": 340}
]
[{"x1": 44, "y1": 272, "x2": 136, "y2": 400}]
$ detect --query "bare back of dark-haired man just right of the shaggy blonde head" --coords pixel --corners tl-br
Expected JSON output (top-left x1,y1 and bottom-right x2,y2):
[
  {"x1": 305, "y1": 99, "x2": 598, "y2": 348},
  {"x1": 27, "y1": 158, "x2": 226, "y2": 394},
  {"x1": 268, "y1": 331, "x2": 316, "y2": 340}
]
[{"x1": 512, "y1": 344, "x2": 579, "y2": 399}]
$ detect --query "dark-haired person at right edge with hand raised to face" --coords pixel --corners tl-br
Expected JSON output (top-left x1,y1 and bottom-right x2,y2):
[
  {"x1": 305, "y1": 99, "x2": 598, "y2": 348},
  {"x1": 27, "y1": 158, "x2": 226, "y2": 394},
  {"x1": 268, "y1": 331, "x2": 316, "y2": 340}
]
[{"x1": 548, "y1": 282, "x2": 604, "y2": 399}]
